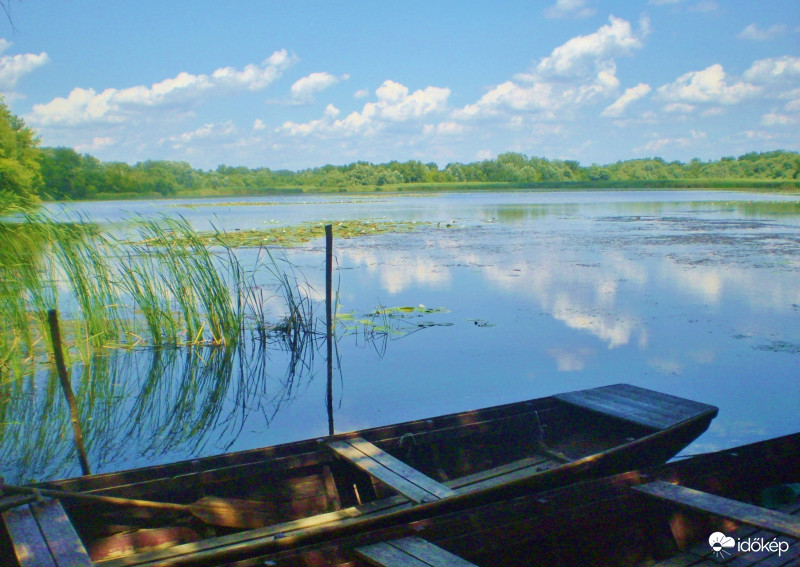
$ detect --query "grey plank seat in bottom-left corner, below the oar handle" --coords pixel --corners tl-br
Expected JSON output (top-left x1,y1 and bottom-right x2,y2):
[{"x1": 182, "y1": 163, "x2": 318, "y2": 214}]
[{"x1": 3, "y1": 499, "x2": 92, "y2": 567}]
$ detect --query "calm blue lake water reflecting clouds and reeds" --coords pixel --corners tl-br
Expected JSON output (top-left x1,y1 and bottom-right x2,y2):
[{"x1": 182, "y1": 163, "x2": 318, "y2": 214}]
[{"x1": 0, "y1": 191, "x2": 800, "y2": 481}]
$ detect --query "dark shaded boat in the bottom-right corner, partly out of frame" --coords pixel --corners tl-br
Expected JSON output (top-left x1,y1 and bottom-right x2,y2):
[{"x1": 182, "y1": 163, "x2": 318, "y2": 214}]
[{"x1": 241, "y1": 433, "x2": 800, "y2": 567}]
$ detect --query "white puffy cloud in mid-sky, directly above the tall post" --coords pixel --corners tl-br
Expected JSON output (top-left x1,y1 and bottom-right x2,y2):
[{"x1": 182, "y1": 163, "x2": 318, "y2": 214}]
[{"x1": 279, "y1": 80, "x2": 450, "y2": 136}]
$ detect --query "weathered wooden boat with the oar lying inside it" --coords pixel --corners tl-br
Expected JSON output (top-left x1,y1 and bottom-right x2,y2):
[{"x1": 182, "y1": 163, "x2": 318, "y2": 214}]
[{"x1": 0, "y1": 384, "x2": 717, "y2": 566}]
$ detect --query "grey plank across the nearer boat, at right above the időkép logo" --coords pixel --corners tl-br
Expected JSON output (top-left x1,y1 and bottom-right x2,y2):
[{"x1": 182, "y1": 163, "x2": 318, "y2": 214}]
[{"x1": 633, "y1": 480, "x2": 800, "y2": 539}]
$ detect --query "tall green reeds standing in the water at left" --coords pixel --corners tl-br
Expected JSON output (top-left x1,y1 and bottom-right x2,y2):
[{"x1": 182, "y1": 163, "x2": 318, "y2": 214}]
[{"x1": 0, "y1": 214, "x2": 314, "y2": 384}]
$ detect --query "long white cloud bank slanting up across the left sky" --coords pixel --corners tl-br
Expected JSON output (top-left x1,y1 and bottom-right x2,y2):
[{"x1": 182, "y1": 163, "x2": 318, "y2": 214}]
[{"x1": 28, "y1": 50, "x2": 295, "y2": 126}]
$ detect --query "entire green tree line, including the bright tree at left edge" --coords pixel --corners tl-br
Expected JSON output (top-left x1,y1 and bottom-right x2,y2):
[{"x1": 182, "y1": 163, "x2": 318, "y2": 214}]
[{"x1": 0, "y1": 98, "x2": 800, "y2": 211}]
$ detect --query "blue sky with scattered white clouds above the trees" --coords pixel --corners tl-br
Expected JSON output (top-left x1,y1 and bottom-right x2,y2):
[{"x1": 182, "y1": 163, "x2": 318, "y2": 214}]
[{"x1": 0, "y1": 0, "x2": 800, "y2": 170}]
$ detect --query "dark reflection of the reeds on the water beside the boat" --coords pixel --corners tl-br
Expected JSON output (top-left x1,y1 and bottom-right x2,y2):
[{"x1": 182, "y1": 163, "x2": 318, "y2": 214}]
[{"x1": 0, "y1": 341, "x2": 312, "y2": 483}]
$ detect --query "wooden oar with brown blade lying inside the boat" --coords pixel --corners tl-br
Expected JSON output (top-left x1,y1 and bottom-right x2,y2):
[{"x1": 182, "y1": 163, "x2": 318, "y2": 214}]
[{"x1": 0, "y1": 484, "x2": 275, "y2": 529}]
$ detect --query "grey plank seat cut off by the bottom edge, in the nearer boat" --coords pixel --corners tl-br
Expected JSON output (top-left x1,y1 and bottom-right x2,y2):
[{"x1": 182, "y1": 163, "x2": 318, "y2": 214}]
[{"x1": 355, "y1": 536, "x2": 475, "y2": 567}]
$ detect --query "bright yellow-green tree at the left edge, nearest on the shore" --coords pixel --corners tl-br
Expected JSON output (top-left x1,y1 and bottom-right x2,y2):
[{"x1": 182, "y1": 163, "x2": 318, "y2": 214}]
[{"x1": 0, "y1": 96, "x2": 42, "y2": 212}]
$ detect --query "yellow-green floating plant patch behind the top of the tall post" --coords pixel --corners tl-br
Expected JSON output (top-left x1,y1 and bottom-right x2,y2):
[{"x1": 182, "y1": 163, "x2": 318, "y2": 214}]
[{"x1": 190, "y1": 220, "x2": 429, "y2": 248}]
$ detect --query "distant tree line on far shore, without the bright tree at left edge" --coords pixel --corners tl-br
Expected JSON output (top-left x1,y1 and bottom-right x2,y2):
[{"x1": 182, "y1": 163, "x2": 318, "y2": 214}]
[{"x1": 39, "y1": 148, "x2": 800, "y2": 199}]
